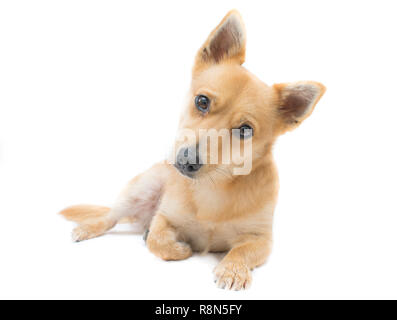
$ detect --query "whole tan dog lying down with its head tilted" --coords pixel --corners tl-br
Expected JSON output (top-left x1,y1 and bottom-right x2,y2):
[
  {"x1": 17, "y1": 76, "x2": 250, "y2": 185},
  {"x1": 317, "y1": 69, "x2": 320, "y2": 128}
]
[{"x1": 61, "y1": 11, "x2": 325, "y2": 290}]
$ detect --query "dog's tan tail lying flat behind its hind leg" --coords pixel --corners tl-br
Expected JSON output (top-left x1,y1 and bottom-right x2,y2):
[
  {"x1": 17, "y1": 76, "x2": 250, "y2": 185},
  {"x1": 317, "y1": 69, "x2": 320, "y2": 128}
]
[{"x1": 59, "y1": 204, "x2": 133, "y2": 224}]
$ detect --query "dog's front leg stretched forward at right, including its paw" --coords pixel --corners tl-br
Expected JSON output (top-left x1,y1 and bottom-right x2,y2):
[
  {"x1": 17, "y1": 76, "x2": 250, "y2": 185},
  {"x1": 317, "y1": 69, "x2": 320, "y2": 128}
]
[{"x1": 214, "y1": 234, "x2": 272, "y2": 290}]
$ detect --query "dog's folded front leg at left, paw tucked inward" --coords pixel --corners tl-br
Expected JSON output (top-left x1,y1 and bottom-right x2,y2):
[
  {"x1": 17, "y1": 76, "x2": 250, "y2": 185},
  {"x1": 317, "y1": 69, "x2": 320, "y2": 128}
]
[{"x1": 146, "y1": 213, "x2": 192, "y2": 260}]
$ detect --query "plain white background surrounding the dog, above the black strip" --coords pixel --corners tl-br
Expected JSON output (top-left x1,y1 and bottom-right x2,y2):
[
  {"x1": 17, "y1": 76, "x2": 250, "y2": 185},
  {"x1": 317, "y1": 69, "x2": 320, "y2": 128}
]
[{"x1": 0, "y1": 0, "x2": 397, "y2": 299}]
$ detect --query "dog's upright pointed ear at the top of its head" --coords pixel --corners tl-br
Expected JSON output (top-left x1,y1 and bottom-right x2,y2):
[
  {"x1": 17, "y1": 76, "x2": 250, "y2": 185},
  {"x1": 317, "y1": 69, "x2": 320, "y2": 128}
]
[{"x1": 194, "y1": 10, "x2": 246, "y2": 70}]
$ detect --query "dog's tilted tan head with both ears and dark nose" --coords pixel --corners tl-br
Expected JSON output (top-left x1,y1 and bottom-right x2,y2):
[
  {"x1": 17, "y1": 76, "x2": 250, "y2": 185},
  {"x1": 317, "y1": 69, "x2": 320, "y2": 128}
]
[{"x1": 174, "y1": 11, "x2": 325, "y2": 181}]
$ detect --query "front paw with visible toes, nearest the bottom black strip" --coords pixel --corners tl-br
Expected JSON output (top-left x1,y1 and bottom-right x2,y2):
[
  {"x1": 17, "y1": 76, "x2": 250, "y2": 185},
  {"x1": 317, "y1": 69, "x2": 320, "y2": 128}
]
[{"x1": 214, "y1": 262, "x2": 252, "y2": 290}]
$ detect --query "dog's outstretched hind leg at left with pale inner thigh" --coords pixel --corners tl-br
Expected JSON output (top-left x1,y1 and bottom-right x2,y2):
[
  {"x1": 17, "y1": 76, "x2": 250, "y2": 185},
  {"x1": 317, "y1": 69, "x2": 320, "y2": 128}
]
[{"x1": 68, "y1": 164, "x2": 168, "y2": 242}]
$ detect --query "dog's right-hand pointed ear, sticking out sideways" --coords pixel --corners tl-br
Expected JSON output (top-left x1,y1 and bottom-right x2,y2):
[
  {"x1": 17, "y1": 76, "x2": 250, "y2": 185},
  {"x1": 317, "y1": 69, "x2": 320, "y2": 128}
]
[{"x1": 273, "y1": 81, "x2": 325, "y2": 131}]
